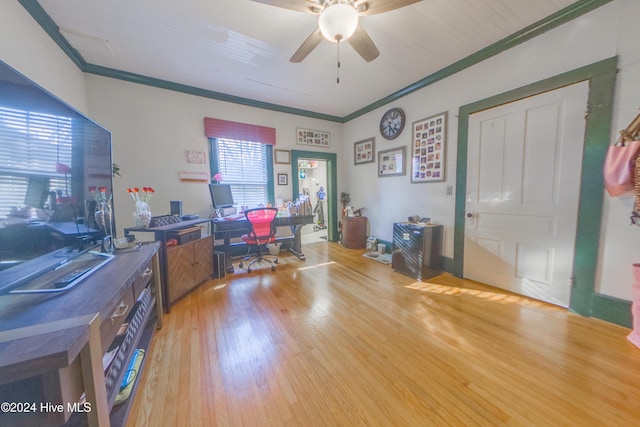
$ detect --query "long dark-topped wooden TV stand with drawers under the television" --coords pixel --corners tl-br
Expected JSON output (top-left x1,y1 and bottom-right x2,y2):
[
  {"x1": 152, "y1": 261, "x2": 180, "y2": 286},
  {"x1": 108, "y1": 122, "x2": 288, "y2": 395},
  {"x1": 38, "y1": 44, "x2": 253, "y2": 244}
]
[{"x1": 0, "y1": 242, "x2": 163, "y2": 427}]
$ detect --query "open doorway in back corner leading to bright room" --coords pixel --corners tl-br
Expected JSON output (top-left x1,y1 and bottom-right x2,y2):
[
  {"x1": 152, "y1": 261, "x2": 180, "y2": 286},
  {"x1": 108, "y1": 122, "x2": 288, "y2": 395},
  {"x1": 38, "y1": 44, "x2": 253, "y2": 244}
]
[{"x1": 291, "y1": 150, "x2": 338, "y2": 242}]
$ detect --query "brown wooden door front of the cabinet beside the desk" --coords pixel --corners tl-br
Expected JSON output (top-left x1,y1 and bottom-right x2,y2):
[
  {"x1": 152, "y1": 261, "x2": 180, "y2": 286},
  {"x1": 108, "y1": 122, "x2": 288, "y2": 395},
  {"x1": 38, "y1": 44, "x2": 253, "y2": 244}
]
[{"x1": 167, "y1": 236, "x2": 213, "y2": 304}]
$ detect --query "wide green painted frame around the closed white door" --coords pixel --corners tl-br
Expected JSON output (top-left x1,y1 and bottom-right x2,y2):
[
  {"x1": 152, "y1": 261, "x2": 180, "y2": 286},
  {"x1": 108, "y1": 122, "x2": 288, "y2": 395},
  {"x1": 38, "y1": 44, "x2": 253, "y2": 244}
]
[{"x1": 453, "y1": 57, "x2": 631, "y2": 327}]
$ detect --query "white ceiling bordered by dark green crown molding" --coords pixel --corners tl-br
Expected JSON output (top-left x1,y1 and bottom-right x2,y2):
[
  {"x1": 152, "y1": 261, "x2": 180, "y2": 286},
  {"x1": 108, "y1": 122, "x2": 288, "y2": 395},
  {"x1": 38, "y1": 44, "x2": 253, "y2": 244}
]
[{"x1": 39, "y1": 0, "x2": 580, "y2": 117}]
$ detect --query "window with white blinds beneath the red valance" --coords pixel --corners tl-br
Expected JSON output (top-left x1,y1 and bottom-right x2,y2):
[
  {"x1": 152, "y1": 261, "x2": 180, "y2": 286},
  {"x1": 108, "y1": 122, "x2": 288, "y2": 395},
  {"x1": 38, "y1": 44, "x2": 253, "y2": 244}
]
[{"x1": 210, "y1": 138, "x2": 273, "y2": 207}]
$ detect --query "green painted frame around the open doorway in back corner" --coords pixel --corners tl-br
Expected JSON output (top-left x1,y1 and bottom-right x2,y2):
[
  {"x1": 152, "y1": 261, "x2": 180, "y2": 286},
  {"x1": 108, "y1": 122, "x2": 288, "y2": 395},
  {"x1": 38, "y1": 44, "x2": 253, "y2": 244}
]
[{"x1": 291, "y1": 150, "x2": 339, "y2": 242}]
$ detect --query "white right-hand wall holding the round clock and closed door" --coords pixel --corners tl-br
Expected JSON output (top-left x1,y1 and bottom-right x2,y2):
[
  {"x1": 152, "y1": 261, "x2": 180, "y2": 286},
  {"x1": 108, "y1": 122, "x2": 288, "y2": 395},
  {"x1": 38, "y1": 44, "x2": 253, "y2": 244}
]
[{"x1": 341, "y1": 0, "x2": 640, "y2": 300}]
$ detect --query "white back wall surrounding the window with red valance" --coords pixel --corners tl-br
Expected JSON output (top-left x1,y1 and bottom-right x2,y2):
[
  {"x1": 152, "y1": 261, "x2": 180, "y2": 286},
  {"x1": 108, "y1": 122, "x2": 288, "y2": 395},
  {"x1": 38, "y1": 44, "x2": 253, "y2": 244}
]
[{"x1": 87, "y1": 75, "x2": 342, "y2": 234}]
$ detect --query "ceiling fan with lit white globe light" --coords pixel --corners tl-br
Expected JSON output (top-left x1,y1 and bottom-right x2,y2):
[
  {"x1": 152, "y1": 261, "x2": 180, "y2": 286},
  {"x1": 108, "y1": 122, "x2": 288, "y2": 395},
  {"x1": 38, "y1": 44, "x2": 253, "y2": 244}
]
[{"x1": 252, "y1": 0, "x2": 422, "y2": 62}]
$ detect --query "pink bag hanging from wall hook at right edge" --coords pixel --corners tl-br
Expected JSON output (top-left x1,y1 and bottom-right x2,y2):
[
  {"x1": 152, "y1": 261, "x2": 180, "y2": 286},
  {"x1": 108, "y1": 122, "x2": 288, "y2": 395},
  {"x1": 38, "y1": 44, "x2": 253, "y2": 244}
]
[{"x1": 604, "y1": 141, "x2": 640, "y2": 197}]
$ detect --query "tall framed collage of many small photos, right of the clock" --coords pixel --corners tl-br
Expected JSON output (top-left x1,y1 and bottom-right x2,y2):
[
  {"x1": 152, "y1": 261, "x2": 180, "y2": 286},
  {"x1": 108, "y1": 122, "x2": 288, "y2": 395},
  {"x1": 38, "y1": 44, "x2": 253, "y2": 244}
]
[{"x1": 411, "y1": 112, "x2": 447, "y2": 183}]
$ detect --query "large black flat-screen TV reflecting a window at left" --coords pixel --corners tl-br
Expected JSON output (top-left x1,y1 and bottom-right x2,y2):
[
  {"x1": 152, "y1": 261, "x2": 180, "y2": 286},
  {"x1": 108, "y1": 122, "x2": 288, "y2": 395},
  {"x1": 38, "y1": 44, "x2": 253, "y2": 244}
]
[{"x1": 0, "y1": 61, "x2": 115, "y2": 295}]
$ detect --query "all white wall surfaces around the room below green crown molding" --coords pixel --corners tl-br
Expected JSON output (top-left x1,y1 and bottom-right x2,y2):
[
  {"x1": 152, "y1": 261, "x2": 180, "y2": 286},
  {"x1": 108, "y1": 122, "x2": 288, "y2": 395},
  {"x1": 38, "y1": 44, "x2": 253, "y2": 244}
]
[{"x1": 0, "y1": 0, "x2": 640, "y2": 300}]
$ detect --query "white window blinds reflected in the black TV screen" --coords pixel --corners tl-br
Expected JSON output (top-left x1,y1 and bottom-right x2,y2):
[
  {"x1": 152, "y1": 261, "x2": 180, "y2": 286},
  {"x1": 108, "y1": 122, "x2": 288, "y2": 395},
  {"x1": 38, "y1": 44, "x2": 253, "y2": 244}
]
[{"x1": 0, "y1": 107, "x2": 73, "y2": 218}]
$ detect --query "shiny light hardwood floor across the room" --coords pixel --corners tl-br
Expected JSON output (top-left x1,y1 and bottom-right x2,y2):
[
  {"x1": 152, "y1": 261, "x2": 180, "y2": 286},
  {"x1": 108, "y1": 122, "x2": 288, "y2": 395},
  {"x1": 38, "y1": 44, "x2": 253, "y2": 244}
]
[{"x1": 128, "y1": 243, "x2": 640, "y2": 427}]
